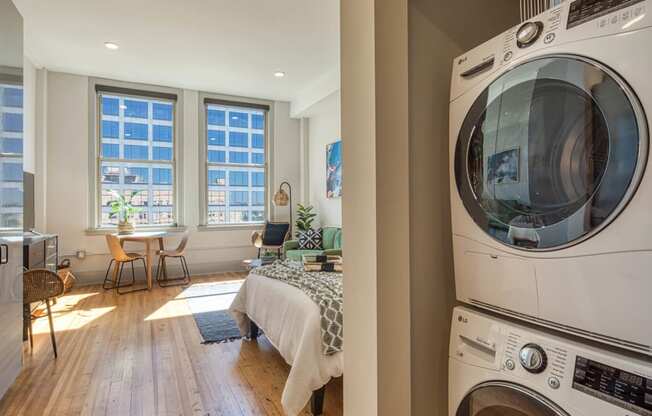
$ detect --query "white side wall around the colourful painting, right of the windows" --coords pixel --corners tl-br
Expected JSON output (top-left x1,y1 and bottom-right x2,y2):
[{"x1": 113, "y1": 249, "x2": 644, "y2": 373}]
[{"x1": 303, "y1": 91, "x2": 346, "y2": 227}]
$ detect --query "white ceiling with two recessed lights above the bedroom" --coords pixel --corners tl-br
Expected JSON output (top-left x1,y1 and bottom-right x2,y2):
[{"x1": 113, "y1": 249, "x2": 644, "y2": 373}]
[{"x1": 14, "y1": 0, "x2": 339, "y2": 101}]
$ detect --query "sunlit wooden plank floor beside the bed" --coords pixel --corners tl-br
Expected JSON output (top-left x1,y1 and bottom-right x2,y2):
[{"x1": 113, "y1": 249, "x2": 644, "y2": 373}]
[{"x1": 0, "y1": 273, "x2": 342, "y2": 416}]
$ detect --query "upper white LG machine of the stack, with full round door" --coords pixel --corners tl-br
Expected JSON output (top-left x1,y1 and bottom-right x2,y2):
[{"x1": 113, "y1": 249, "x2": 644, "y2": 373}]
[{"x1": 450, "y1": 0, "x2": 652, "y2": 355}]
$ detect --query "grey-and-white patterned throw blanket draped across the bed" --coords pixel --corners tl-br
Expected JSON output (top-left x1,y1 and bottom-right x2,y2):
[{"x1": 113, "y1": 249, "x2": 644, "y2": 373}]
[{"x1": 255, "y1": 260, "x2": 344, "y2": 355}]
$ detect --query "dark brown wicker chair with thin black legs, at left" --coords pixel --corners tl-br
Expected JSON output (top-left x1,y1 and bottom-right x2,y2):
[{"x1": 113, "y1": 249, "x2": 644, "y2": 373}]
[{"x1": 23, "y1": 269, "x2": 64, "y2": 358}]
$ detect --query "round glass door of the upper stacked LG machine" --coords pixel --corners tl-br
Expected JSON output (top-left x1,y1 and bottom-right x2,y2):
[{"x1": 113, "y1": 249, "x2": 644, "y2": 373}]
[{"x1": 455, "y1": 55, "x2": 648, "y2": 250}]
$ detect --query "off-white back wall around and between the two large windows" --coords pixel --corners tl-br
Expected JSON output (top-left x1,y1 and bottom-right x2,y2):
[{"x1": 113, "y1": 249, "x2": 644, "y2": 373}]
[{"x1": 42, "y1": 71, "x2": 299, "y2": 284}]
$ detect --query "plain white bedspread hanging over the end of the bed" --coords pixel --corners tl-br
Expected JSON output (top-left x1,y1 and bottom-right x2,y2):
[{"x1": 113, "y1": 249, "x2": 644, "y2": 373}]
[{"x1": 229, "y1": 270, "x2": 344, "y2": 416}]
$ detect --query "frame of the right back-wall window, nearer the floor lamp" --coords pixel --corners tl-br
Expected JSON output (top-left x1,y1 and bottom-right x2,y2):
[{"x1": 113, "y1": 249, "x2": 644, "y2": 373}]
[{"x1": 198, "y1": 92, "x2": 274, "y2": 231}]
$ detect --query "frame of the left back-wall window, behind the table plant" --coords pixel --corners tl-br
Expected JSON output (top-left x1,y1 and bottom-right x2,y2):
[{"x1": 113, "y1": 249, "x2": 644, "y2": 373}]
[{"x1": 87, "y1": 78, "x2": 186, "y2": 234}]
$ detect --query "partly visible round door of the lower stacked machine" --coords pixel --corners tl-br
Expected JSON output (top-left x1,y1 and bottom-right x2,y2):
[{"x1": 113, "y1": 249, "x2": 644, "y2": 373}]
[{"x1": 455, "y1": 381, "x2": 568, "y2": 416}]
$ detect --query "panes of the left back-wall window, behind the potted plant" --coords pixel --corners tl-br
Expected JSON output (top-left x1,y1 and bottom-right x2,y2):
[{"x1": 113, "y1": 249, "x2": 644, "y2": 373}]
[{"x1": 96, "y1": 86, "x2": 176, "y2": 227}]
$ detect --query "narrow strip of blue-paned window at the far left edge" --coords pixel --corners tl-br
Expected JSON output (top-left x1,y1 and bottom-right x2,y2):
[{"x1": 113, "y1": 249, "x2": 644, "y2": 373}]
[{"x1": 0, "y1": 82, "x2": 23, "y2": 229}]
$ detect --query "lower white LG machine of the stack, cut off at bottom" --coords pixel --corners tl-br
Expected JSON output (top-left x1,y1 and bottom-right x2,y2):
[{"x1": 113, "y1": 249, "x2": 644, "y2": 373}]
[{"x1": 448, "y1": 307, "x2": 652, "y2": 416}]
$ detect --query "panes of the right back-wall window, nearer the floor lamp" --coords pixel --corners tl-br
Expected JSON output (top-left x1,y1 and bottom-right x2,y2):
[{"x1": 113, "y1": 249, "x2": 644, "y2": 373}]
[{"x1": 203, "y1": 98, "x2": 267, "y2": 225}]
